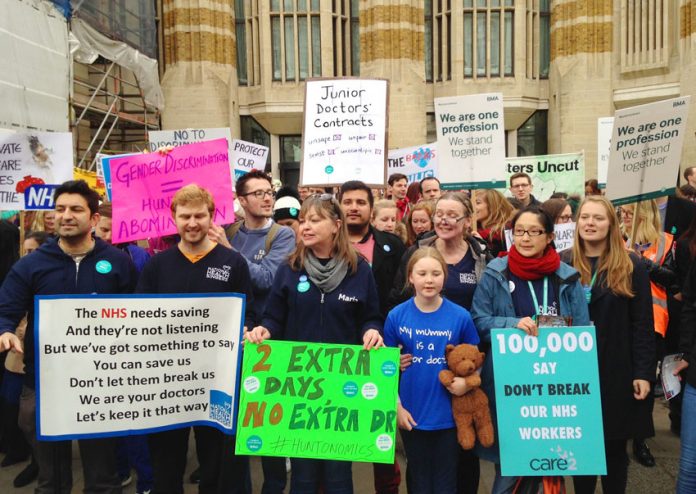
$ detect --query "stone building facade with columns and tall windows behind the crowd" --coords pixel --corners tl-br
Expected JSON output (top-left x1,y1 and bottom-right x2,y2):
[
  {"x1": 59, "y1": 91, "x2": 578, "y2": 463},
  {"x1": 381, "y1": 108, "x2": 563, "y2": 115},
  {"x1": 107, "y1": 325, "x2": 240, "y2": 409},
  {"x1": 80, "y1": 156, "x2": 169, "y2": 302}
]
[{"x1": 160, "y1": 0, "x2": 696, "y2": 182}]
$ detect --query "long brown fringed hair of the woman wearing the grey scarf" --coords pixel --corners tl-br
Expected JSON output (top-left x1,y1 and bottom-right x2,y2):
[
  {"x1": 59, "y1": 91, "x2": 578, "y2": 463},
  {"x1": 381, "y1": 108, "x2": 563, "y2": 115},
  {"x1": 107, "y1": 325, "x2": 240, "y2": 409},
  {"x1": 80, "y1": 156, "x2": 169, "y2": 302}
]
[{"x1": 288, "y1": 194, "x2": 358, "y2": 273}]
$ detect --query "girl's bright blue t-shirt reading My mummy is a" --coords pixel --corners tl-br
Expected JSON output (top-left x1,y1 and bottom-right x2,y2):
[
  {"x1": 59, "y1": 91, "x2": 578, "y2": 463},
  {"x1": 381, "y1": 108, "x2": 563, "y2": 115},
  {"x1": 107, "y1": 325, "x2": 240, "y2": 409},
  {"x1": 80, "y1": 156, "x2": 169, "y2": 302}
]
[{"x1": 384, "y1": 298, "x2": 479, "y2": 430}]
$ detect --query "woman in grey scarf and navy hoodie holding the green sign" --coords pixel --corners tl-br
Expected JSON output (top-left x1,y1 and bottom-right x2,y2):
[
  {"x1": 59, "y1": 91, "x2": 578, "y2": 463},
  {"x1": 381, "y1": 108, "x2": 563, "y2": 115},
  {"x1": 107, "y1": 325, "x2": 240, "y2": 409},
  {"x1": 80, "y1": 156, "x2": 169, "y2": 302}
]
[{"x1": 245, "y1": 194, "x2": 383, "y2": 493}]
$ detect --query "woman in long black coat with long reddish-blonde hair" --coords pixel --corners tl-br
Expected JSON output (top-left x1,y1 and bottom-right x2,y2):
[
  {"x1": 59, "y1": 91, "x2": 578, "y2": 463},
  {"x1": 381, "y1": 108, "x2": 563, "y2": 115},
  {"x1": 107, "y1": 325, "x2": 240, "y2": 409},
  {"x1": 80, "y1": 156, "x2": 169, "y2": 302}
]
[{"x1": 564, "y1": 195, "x2": 655, "y2": 494}]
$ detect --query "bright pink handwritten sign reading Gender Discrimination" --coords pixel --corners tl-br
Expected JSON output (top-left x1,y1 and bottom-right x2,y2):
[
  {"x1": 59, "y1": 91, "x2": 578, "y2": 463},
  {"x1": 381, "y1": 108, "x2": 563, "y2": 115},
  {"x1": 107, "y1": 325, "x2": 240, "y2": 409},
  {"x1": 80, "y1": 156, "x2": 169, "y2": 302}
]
[{"x1": 109, "y1": 139, "x2": 234, "y2": 244}]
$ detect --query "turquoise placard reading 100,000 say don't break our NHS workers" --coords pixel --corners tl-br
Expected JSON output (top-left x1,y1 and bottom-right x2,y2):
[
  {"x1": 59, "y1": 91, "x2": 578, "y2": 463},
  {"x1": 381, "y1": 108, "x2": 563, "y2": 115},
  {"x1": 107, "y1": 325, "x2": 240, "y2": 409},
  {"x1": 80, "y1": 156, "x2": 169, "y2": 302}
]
[{"x1": 491, "y1": 326, "x2": 606, "y2": 476}]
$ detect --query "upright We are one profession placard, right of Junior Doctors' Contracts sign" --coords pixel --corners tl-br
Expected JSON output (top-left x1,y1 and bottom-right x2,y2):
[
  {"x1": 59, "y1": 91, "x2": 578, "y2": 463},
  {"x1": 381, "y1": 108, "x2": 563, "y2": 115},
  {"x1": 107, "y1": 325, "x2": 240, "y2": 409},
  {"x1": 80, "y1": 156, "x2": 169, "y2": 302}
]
[{"x1": 435, "y1": 93, "x2": 507, "y2": 189}]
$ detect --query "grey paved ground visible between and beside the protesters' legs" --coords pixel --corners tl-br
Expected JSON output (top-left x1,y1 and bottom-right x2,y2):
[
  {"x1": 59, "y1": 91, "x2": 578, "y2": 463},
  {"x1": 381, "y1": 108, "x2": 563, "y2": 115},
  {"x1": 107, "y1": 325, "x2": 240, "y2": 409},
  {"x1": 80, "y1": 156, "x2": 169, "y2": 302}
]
[{"x1": 0, "y1": 401, "x2": 679, "y2": 494}]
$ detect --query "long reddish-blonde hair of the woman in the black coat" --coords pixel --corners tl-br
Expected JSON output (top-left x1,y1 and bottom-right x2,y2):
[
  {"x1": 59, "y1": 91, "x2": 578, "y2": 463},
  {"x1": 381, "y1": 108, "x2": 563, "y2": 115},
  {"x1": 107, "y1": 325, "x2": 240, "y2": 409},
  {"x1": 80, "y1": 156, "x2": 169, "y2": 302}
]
[{"x1": 572, "y1": 196, "x2": 635, "y2": 298}]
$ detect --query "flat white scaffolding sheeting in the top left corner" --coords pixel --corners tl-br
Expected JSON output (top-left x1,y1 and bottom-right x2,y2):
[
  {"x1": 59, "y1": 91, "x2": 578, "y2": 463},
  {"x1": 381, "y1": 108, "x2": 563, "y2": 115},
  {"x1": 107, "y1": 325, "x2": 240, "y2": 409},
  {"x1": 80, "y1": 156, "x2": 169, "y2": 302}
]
[{"x1": 0, "y1": 0, "x2": 71, "y2": 132}]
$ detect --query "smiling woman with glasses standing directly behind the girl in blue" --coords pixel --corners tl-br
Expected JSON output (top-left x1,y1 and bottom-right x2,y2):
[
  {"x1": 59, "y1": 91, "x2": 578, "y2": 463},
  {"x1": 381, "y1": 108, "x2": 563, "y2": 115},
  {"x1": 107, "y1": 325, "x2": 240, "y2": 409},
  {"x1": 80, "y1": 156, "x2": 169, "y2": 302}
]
[{"x1": 389, "y1": 192, "x2": 490, "y2": 493}]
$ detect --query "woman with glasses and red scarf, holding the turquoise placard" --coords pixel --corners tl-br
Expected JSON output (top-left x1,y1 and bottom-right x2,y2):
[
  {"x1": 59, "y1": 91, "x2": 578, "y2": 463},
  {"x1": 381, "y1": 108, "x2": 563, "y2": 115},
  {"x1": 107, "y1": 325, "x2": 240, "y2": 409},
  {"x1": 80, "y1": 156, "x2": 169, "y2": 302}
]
[{"x1": 472, "y1": 206, "x2": 590, "y2": 493}]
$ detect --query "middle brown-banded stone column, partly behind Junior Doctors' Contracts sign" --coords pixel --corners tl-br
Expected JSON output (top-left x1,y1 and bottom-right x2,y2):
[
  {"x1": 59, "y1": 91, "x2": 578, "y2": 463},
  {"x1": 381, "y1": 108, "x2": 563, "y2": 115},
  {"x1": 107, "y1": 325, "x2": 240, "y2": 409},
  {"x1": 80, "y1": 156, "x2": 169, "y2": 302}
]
[{"x1": 360, "y1": 0, "x2": 426, "y2": 149}]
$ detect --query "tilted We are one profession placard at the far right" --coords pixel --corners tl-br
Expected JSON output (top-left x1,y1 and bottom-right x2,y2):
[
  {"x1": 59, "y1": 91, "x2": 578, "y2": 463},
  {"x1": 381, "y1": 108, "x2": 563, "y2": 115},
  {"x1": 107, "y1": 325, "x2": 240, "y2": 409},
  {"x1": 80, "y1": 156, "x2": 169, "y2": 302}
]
[{"x1": 606, "y1": 96, "x2": 691, "y2": 205}]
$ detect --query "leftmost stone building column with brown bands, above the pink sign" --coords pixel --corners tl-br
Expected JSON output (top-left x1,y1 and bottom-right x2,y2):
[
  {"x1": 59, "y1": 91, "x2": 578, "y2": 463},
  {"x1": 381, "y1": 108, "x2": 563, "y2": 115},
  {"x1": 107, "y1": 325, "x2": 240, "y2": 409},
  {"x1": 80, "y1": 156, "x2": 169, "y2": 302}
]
[{"x1": 161, "y1": 0, "x2": 239, "y2": 136}]
